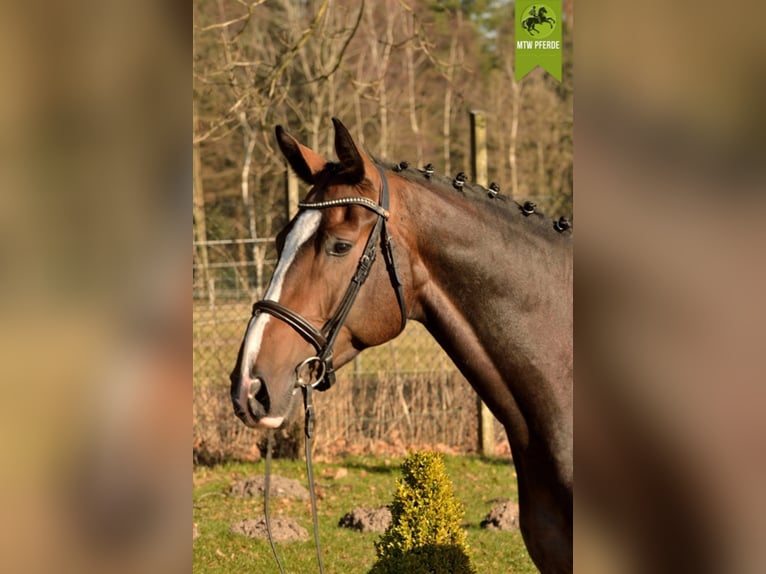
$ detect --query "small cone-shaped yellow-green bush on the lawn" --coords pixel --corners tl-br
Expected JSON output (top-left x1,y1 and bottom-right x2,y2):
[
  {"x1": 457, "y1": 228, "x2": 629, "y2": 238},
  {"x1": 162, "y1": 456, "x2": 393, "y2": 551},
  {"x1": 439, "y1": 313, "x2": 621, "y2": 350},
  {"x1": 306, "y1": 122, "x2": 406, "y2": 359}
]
[{"x1": 371, "y1": 452, "x2": 475, "y2": 574}]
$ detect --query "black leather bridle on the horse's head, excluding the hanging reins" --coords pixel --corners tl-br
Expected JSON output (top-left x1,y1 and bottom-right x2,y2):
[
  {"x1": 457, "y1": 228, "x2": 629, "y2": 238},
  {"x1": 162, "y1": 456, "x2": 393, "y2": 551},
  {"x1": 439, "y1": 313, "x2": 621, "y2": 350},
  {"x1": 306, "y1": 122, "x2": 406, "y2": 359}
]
[{"x1": 253, "y1": 166, "x2": 407, "y2": 391}]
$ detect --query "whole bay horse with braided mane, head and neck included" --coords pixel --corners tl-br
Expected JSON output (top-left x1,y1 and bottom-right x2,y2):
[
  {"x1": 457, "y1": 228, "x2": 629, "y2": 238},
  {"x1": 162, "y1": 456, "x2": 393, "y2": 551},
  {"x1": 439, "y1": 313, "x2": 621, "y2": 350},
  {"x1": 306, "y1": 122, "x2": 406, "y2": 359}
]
[{"x1": 230, "y1": 118, "x2": 574, "y2": 574}]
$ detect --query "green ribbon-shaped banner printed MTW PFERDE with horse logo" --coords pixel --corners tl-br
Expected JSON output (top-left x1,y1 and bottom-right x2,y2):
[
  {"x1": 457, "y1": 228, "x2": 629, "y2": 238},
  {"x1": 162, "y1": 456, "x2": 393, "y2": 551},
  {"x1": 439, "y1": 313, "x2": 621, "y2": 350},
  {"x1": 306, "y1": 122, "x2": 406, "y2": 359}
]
[{"x1": 516, "y1": 0, "x2": 561, "y2": 82}]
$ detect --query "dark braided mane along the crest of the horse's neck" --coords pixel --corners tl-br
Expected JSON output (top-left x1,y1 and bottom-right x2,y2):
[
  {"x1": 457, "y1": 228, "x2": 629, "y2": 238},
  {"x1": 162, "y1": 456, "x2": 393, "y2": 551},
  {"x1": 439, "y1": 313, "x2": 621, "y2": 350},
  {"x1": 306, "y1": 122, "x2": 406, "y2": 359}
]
[{"x1": 380, "y1": 159, "x2": 572, "y2": 241}]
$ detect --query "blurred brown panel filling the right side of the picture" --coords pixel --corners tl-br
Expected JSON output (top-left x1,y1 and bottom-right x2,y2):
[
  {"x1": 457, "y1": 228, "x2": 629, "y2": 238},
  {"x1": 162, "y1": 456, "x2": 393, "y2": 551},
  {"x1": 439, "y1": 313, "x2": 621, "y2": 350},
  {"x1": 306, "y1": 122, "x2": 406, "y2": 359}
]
[{"x1": 575, "y1": 0, "x2": 766, "y2": 573}]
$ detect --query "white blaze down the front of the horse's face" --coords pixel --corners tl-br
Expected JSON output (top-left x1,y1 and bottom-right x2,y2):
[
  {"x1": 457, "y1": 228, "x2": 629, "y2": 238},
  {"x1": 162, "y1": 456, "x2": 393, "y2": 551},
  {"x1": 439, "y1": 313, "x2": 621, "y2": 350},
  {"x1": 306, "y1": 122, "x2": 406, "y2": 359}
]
[{"x1": 242, "y1": 210, "x2": 322, "y2": 380}]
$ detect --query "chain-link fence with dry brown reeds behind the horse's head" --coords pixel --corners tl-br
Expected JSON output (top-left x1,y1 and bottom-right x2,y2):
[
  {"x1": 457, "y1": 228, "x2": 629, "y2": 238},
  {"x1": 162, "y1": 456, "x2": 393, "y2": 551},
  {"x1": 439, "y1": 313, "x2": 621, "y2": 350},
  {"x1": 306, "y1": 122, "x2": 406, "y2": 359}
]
[{"x1": 193, "y1": 241, "x2": 507, "y2": 462}]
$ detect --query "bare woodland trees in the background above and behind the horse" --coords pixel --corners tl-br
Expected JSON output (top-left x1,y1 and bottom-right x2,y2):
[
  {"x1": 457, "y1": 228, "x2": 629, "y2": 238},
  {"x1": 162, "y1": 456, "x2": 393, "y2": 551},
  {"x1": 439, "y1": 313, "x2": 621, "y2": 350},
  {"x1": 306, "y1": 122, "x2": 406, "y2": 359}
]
[{"x1": 193, "y1": 0, "x2": 573, "y2": 300}]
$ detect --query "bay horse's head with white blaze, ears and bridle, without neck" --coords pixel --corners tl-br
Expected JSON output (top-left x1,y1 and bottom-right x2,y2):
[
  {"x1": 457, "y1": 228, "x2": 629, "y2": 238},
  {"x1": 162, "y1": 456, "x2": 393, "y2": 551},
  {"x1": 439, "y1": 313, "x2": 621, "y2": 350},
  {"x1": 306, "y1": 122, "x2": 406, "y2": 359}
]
[{"x1": 230, "y1": 118, "x2": 406, "y2": 428}]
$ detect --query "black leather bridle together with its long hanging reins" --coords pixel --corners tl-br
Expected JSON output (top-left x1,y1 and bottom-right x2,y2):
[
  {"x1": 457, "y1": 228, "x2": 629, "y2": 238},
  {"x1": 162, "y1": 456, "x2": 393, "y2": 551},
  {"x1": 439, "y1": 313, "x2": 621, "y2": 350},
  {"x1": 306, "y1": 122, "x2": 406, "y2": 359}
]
[{"x1": 253, "y1": 166, "x2": 407, "y2": 574}]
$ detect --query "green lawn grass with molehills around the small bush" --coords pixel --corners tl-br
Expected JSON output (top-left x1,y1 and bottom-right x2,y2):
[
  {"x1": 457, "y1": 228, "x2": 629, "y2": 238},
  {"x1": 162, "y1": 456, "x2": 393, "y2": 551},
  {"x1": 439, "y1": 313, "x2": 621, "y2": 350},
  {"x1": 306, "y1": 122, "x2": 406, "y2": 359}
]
[{"x1": 193, "y1": 456, "x2": 537, "y2": 574}]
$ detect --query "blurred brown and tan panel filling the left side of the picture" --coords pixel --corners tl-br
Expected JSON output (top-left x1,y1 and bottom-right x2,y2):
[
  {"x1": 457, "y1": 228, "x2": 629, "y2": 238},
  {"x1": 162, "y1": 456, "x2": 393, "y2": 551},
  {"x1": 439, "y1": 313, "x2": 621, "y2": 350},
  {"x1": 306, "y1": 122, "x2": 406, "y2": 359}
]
[{"x1": 0, "y1": 0, "x2": 192, "y2": 573}]
